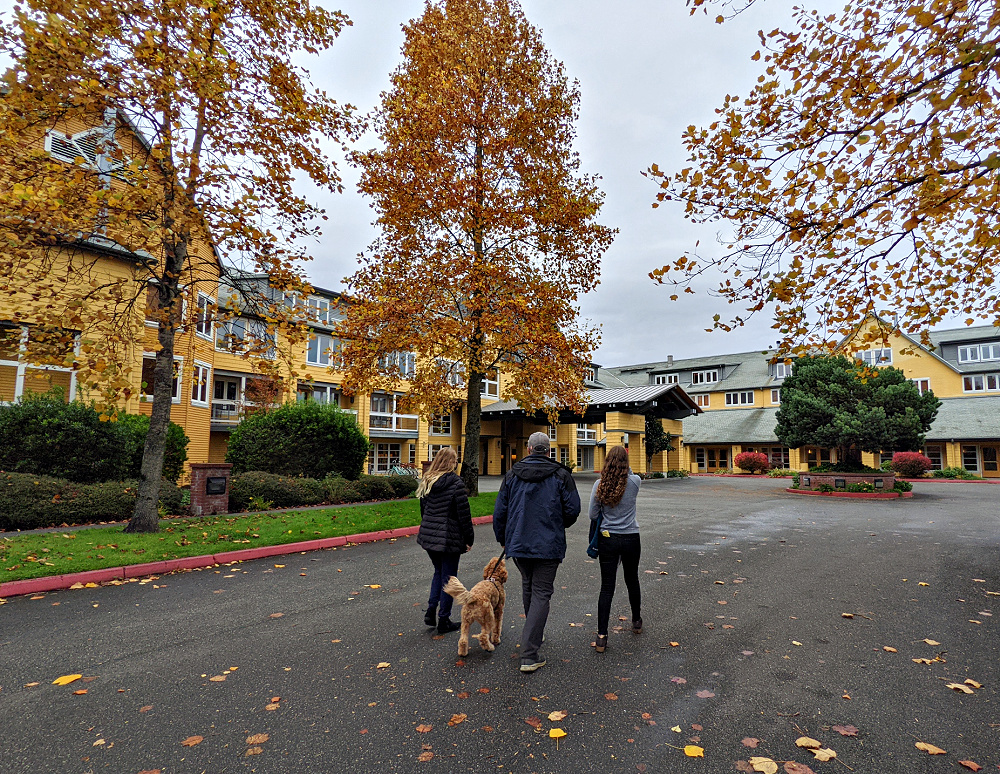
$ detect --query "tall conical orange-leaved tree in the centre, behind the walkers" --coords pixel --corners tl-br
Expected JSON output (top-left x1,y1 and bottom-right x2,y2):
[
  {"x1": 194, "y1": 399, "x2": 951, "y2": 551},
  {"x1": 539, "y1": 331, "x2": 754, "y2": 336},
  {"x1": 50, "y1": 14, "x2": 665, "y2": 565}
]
[{"x1": 339, "y1": 0, "x2": 615, "y2": 493}]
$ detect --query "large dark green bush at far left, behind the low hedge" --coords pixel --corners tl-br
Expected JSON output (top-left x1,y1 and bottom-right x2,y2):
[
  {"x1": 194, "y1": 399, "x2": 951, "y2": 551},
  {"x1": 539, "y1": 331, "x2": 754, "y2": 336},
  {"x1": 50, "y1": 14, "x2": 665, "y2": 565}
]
[{"x1": 0, "y1": 390, "x2": 188, "y2": 484}]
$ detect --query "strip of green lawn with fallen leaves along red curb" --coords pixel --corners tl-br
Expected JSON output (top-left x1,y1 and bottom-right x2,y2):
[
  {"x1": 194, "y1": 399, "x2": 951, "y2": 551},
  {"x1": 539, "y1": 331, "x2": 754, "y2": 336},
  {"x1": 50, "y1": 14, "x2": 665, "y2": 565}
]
[{"x1": 0, "y1": 493, "x2": 496, "y2": 582}]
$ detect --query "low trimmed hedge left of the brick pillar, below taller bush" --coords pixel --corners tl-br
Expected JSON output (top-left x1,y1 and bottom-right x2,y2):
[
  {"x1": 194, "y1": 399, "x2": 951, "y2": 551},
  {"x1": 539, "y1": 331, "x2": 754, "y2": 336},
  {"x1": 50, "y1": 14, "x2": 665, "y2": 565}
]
[{"x1": 0, "y1": 472, "x2": 181, "y2": 530}]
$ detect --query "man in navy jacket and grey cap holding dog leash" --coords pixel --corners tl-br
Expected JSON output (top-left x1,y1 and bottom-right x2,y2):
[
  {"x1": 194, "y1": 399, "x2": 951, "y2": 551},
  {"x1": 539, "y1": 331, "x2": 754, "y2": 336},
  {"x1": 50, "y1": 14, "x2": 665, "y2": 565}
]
[{"x1": 493, "y1": 433, "x2": 580, "y2": 672}]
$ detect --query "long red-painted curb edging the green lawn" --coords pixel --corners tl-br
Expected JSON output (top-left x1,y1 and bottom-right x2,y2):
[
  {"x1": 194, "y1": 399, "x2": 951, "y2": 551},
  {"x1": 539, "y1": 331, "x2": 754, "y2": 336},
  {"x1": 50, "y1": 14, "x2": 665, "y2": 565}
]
[{"x1": 0, "y1": 516, "x2": 493, "y2": 597}]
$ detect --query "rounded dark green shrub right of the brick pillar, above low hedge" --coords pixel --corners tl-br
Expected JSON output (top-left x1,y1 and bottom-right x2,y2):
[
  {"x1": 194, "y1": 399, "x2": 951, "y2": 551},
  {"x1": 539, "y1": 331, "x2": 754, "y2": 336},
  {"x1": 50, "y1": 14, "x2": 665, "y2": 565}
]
[{"x1": 226, "y1": 401, "x2": 368, "y2": 480}]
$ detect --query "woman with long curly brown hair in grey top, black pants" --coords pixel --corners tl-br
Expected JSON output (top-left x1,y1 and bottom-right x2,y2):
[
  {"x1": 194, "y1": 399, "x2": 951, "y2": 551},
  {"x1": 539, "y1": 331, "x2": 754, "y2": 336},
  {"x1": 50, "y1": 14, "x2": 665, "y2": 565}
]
[{"x1": 590, "y1": 446, "x2": 642, "y2": 653}]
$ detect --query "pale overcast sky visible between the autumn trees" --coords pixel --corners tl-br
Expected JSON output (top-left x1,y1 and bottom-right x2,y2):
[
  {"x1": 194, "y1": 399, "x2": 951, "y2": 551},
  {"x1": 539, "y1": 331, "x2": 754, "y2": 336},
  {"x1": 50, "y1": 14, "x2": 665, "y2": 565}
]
[{"x1": 0, "y1": 0, "x2": 812, "y2": 366}]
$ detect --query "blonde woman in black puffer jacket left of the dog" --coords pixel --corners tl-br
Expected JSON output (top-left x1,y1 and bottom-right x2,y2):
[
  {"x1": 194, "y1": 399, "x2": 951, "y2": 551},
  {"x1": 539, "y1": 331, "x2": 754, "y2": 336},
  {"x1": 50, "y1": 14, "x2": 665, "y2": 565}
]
[{"x1": 417, "y1": 448, "x2": 476, "y2": 634}]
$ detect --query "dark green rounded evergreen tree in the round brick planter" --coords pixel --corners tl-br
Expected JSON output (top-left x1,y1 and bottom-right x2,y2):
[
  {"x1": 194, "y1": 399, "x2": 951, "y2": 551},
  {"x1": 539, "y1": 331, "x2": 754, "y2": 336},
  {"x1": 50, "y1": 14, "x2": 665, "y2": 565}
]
[{"x1": 774, "y1": 355, "x2": 941, "y2": 466}]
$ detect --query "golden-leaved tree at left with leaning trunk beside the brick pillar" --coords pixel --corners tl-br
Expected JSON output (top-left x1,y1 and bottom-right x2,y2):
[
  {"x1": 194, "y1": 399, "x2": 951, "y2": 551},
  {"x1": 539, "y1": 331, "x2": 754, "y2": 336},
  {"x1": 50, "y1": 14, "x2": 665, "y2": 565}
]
[{"x1": 0, "y1": 0, "x2": 349, "y2": 531}]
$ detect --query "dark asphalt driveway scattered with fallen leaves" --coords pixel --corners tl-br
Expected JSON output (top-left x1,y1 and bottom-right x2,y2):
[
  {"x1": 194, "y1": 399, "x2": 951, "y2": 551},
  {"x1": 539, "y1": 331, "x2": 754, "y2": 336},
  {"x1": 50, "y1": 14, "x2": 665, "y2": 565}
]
[{"x1": 0, "y1": 478, "x2": 1000, "y2": 774}]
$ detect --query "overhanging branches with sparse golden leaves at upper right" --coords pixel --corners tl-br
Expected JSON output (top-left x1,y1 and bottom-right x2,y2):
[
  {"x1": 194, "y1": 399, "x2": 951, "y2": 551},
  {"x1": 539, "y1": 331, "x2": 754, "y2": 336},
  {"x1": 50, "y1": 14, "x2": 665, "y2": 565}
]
[{"x1": 648, "y1": 0, "x2": 1000, "y2": 352}]
